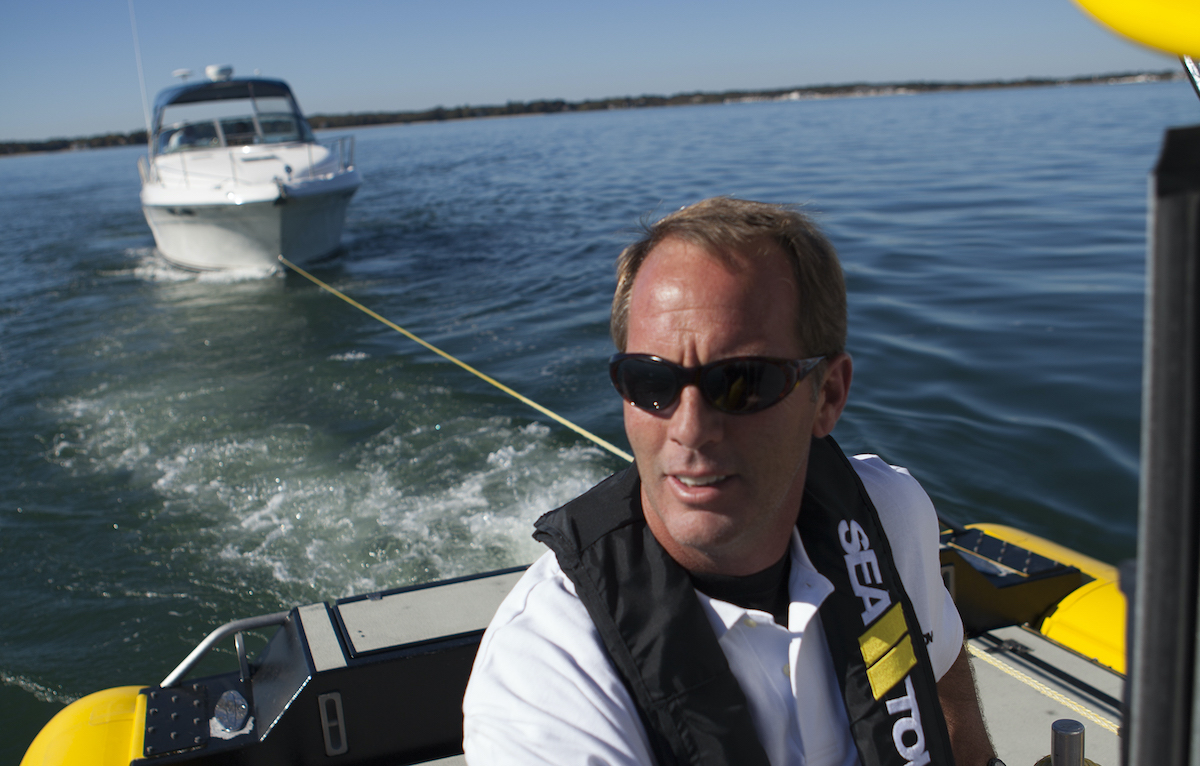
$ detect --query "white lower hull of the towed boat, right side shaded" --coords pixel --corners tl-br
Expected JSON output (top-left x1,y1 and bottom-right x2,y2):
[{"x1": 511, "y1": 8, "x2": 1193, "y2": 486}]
[{"x1": 142, "y1": 173, "x2": 359, "y2": 271}]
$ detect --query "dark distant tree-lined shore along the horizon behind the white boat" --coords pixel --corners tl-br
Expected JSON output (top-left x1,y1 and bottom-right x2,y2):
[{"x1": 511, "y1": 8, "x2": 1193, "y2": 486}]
[{"x1": 0, "y1": 70, "x2": 1182, "y2": 155}]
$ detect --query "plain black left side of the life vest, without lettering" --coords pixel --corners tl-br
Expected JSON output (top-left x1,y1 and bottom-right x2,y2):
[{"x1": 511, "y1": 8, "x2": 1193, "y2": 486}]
[{"x1": 534, "y1": 467, "x2": 769, "y2": 766}]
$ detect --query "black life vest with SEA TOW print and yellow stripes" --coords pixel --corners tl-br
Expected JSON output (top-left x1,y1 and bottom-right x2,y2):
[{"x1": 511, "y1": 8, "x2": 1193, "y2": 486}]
[{"x1": 534, "y1": 437, "x2": 954, "y2": 766}]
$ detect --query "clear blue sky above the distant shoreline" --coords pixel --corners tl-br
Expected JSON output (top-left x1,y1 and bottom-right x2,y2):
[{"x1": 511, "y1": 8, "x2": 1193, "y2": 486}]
[{"x1": 0, "y1": 0, "x2": 1178, "y2": 140}]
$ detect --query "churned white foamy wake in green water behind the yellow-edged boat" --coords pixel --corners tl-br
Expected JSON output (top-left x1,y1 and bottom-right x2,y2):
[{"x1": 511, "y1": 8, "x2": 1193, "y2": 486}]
[{"x1": 48, "y1": 387, "x2": 611, "y2": 604}]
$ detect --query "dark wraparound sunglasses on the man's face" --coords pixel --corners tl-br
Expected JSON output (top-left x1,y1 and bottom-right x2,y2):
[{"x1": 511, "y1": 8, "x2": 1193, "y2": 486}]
[{"x1": 608, "y1": 354, "x2": 824, "y2": 415}]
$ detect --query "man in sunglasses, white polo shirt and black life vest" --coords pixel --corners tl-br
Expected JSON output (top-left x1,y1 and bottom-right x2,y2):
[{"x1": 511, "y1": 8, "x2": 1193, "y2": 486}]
[{"x1": 463, "y1": 198, "x2": 994, "y2": 766}]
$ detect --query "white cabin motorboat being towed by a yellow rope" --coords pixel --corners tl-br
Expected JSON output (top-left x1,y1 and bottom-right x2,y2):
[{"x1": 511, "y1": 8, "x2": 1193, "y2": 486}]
[{"x1": 138, "y1": 66, "x2": 362, "y2": 270}]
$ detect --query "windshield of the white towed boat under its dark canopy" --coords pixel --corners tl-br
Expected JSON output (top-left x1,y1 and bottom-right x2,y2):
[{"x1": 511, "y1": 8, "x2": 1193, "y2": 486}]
[{"x1": 155, "y1": 96, "x2": 313, "y2": 154}]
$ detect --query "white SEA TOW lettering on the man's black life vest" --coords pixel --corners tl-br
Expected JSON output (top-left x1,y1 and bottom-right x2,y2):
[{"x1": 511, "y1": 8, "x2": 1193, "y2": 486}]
[{"x1": 838, "y1": 521, "x2": 929, "y2": 766}]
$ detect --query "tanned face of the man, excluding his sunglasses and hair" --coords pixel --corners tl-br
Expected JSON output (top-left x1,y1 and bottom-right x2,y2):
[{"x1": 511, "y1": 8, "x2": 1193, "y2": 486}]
[{"x1": 625, "y1": 239, "x2": 850, "y2": 575}]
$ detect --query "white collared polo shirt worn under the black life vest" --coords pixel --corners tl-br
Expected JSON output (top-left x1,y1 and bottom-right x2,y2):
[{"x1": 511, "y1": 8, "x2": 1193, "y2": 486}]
[{"x1": 463, "y1": 455, "x2": 962, "y2": 766}]
